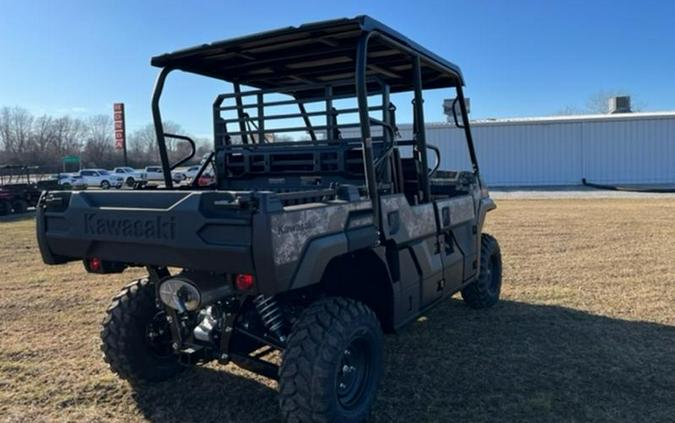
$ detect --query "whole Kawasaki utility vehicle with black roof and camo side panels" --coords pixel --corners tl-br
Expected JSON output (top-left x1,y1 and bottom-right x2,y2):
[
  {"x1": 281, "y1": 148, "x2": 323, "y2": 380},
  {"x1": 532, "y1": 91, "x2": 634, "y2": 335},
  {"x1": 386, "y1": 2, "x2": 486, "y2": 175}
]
[{"x1": 37, "y1": 16, "x2": 501, "y2": 422}]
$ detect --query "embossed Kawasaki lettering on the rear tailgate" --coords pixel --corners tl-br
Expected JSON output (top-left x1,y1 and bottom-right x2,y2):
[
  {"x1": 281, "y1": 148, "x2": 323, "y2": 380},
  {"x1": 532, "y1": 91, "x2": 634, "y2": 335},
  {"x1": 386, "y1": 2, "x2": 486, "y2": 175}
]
[{"x1": 84, "y1": 213, "x2": 176, "y2": 240}]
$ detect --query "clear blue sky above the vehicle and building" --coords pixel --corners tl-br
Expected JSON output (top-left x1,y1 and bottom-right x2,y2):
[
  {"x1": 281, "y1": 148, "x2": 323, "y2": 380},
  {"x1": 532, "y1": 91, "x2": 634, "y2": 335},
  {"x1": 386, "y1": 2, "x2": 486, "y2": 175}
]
[{"x1": 0, "y1": 0, "x2": 675, "y2": 136}]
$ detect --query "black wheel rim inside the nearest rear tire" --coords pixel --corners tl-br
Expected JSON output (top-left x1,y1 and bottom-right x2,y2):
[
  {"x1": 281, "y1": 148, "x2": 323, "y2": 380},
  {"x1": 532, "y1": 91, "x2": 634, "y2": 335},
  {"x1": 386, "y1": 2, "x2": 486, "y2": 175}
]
[{"x1": 336, "y1": 338, "x2": 372, "y2": 410}]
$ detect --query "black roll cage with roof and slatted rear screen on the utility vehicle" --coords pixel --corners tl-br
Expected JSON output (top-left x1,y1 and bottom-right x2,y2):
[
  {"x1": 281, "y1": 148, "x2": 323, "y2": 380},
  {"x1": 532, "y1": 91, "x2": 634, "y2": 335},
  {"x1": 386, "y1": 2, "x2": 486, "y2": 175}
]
[{"x1": 151, "y1": 16, "x2": 480, "y2": 234}]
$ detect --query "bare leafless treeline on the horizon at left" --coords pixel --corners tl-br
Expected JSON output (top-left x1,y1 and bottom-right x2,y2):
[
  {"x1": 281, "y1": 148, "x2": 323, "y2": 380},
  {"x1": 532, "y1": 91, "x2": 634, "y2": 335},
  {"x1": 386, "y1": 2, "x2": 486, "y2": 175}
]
[{"x1": 0, "y1": 107, "x2": 210, "y2": 170}]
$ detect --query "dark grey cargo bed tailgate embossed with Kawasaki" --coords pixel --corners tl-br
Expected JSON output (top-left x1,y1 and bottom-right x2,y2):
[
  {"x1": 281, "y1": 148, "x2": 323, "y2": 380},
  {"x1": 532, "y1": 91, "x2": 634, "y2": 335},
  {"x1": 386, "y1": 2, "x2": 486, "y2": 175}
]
[{"x1": 37, "y1": 191, "x2": 253, "y2": 273}]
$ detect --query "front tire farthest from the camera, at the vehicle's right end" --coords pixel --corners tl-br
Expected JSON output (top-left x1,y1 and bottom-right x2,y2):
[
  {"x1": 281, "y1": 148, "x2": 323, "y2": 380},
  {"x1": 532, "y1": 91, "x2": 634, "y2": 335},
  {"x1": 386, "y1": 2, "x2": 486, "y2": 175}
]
[{"x1": 462, "y1": 234, "x2": 502, "y2": 308}]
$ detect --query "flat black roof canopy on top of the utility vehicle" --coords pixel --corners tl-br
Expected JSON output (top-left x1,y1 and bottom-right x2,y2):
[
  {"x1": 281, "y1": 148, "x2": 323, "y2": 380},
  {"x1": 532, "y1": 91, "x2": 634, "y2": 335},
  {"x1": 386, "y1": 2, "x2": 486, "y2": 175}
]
[{"x1": 151, "y1": 16, "x2": 463, "y2": 94}]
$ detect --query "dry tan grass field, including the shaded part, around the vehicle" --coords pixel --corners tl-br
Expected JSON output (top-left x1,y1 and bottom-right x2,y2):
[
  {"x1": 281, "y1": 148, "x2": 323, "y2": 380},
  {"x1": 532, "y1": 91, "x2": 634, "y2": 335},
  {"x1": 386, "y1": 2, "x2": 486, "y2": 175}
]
[{"x1": 0, "y1": 199, "x2": 675, "y2": 422}]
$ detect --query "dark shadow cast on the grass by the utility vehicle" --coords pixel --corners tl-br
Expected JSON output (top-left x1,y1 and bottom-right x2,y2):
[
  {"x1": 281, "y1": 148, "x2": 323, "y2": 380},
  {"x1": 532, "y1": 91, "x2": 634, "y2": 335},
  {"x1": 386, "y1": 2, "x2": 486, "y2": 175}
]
[{"x1": 129, "y1": 300, "x2": 675, "y2": 422}]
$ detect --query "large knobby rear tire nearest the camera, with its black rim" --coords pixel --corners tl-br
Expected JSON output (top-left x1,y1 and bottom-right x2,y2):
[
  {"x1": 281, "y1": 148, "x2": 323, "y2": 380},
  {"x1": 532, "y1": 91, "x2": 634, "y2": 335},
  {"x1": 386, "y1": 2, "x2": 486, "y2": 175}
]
[{"x1": 279, "y1": 297, "x2": 383, "y2": 423}]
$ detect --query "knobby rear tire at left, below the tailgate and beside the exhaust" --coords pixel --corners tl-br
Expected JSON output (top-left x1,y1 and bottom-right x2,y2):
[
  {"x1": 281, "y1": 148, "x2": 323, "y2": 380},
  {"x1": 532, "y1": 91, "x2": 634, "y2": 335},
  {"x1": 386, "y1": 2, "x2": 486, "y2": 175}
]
[{"x1": 101, "y1": 279, "x2": 185, "y2": 383}]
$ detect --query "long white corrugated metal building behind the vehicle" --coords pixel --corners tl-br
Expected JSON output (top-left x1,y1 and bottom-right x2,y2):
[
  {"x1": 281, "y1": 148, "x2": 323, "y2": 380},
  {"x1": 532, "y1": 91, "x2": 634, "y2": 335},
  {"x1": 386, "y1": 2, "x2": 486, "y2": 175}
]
[{"x1": 401, "y1": 112, "x2": 675, "y2": 186}]
